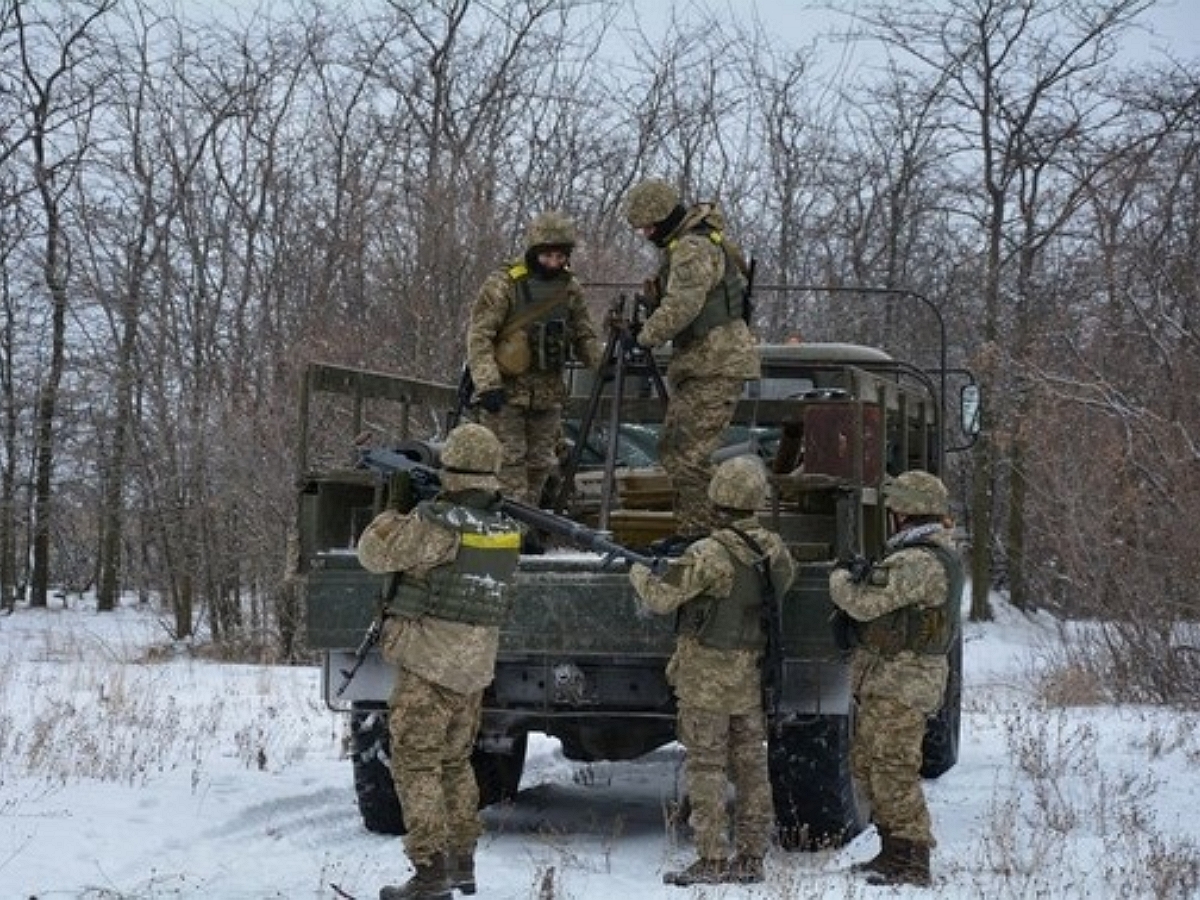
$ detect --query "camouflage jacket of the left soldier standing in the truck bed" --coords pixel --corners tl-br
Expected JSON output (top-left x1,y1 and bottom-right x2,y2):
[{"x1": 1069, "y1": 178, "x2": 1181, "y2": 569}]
[{"x1": 467, "y1": 260, "x2": 604, "y2": 409}]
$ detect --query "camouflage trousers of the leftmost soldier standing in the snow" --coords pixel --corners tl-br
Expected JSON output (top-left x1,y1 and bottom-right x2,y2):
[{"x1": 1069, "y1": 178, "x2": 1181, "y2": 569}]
[{"x1": 388, "y1": 670, "x2": 484, "y2": 865}]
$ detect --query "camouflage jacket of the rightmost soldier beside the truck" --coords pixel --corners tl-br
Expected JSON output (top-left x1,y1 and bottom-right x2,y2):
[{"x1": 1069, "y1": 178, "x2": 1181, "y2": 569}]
[{"x1": 829, "y1": 528, "x2": 960, "y2": 715}]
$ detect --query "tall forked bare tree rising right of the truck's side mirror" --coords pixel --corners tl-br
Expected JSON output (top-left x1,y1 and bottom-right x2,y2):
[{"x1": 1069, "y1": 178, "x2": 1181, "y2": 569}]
[{"x1": 869, "y1": 0, "x2": 1148, "y2": 619}]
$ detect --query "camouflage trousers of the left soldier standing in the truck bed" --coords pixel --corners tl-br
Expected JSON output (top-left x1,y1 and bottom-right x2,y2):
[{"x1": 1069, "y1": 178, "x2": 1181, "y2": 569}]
[{"x1": 479, "y1": 404, "x2": 563, "y2": 506}]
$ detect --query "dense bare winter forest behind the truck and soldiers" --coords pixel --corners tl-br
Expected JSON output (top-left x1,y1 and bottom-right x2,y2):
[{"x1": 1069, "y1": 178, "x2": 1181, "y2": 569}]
[{"x1": 0, "y1": 0, "x2": 1200, "y2": 702}]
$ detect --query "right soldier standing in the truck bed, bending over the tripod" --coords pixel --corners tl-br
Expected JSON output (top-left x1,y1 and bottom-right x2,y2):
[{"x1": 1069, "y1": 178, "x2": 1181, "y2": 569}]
[{"x1": 625, "y1": 179, "x2": 761, "y2": 539}]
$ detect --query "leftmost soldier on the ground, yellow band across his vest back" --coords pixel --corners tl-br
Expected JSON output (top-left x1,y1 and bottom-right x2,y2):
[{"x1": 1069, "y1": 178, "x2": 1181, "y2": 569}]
[{"x1": 358, "y1": 424, "x2": 521, "y2": 900}]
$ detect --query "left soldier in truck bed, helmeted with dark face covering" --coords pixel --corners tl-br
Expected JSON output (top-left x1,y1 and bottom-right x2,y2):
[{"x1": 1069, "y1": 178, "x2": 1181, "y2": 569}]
[{"x1": 467, "y1": 211, "x2": 604, "y2": 505}]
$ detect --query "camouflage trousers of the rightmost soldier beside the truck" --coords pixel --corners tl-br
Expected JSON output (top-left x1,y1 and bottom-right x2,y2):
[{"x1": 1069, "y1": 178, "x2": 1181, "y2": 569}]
[{"x1": 850, "y1": 696, "x2": 935, "y2": 846}]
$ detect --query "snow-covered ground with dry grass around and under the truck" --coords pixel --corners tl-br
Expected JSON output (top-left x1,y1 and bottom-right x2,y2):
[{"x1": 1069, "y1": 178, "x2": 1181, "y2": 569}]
[{"x1": 0, "y1": 598, "x2": 1200, "y2": 900}]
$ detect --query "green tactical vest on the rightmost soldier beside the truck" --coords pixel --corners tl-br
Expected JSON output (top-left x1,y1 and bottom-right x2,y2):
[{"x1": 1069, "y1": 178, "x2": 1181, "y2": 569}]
[{"x1": 854, "y1": 540, "x2": 966, "y2": 656}]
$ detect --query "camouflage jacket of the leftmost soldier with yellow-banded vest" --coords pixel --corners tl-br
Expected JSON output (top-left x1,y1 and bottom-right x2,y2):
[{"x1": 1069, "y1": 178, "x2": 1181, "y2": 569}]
[{"x1": 358, "y1": 510, "x2": 500, "y2": 694}]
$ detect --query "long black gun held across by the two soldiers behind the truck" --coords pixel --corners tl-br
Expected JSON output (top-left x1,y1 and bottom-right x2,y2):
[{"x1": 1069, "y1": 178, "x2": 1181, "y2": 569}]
[{"x1": 359, "y1": 446, "x2": 670, "y2": 575}]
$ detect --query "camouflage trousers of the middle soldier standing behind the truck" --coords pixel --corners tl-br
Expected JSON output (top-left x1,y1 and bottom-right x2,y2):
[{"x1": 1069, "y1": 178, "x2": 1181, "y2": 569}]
[{"x1": 678, "y1": 707, "x2": 775, "y2": 859}]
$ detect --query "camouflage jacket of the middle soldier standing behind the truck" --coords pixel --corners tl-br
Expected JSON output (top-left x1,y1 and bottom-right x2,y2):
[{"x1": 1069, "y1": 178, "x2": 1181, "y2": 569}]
[{"x1": 629, "y1": 518, "x2": 796, "y2": 715}]
